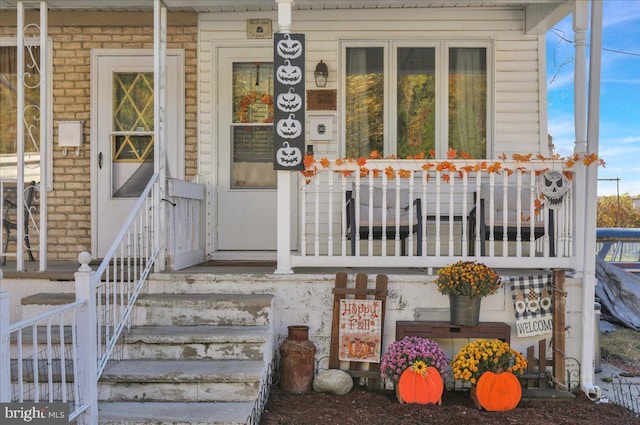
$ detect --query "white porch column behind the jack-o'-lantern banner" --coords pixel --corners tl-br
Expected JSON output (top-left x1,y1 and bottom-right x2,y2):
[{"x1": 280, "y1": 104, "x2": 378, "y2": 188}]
[{"x1": 274, "y1": 0, "x2": 294, "y2": 274}]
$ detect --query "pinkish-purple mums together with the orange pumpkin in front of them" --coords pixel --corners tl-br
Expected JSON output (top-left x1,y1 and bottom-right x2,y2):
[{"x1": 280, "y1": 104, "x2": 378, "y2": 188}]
[{"x1": 380, "y1": 336, "x2": 449, "y2": 404}]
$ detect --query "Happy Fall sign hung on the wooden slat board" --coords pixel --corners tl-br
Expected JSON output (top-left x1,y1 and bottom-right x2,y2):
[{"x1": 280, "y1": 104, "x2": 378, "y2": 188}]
[{"x1": 339, "y1": 299, "x2": 382, "y2": 363}]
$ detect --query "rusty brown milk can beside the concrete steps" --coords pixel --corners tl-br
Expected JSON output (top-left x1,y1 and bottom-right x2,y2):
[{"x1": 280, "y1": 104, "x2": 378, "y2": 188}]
[{"x1": 280, "y1": 326, "x2": 316, "y2": 393}]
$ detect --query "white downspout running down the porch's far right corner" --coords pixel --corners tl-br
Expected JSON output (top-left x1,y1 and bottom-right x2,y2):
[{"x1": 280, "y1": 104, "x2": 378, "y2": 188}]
[{"x1": 580, "y1": 0, "x2": 602, "y2": 400}]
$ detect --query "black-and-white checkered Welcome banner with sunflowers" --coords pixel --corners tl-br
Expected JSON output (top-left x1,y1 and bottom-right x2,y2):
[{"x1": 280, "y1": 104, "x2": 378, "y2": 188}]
[{"x1": 511, "y1": 275, "x2": 553, "y2": 337}]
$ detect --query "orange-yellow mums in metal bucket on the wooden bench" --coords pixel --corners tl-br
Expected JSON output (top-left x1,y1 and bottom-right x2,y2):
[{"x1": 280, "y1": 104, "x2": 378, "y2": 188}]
[{"x1": 436, "y1": 261, "x2": 502, "y2": 326}]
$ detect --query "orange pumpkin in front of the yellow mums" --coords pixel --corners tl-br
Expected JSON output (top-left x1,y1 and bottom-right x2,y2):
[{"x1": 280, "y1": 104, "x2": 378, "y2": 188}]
[{"x1": 476, "y1": 371, "x2": 522, "y2": 412}]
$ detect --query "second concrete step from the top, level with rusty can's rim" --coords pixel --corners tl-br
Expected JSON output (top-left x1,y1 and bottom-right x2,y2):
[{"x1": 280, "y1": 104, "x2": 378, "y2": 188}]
[{"x1": 123, "y1": 325, "x2": 268, "y2": 360}]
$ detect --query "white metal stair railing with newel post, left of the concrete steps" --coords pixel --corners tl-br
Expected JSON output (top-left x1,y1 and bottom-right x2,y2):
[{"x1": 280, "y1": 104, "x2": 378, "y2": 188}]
[{"x1": 0, "y1": 174, "x2": 168, "y2": 424}]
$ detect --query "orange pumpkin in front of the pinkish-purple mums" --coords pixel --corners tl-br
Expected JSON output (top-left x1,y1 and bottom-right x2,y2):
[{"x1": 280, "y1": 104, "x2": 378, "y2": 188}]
[{"x1": 398, "y1": 366, "x2": 444, "y2": 404}]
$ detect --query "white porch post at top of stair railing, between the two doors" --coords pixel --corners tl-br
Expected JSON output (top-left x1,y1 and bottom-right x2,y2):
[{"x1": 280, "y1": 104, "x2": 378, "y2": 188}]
[{"x1": 153, "y1": 0, "x2": 168, "y2": 272}]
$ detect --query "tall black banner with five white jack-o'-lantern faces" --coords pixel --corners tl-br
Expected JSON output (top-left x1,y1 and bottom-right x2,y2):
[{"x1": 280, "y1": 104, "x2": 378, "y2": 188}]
[{"x1": 273, "y1": 33, "x2": 305, "y2": 171}]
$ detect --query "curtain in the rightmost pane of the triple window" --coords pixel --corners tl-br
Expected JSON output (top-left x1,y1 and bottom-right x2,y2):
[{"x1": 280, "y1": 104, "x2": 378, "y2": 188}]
[{"x1": 449, "y1": 48, "x2": 487, "y2": 159}]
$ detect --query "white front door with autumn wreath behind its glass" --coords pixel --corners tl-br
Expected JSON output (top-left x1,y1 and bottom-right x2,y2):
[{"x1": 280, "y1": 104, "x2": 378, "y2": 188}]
[{"x1": 217, "y1": 47, "x2": 284, "y2": 251}]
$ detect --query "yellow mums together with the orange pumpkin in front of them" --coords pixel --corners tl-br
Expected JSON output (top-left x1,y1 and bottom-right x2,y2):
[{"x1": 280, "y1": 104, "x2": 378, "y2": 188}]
[{"x1": 451, "y1": 339, "x2": 527, "y2": 411}]
